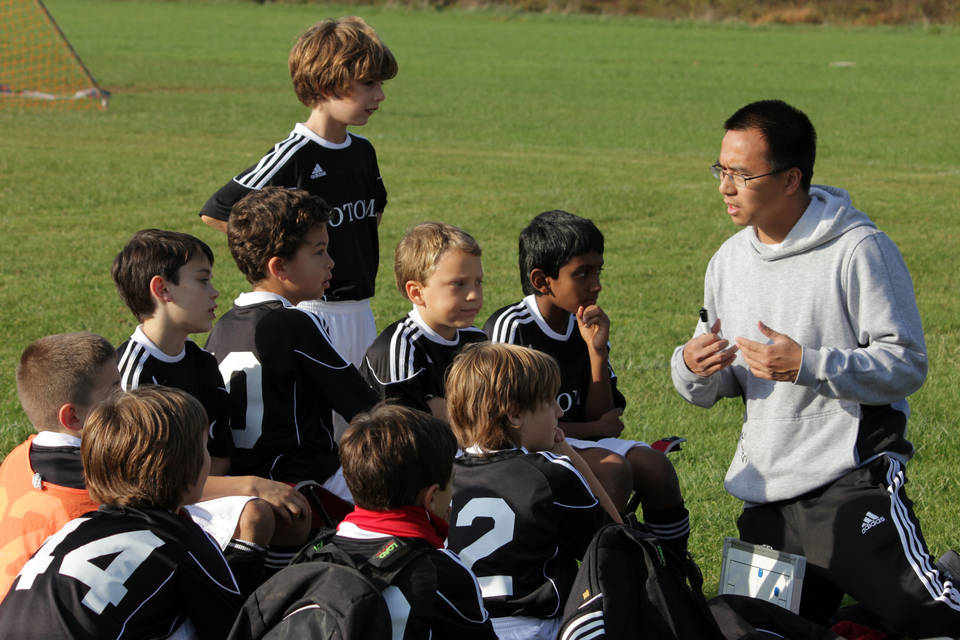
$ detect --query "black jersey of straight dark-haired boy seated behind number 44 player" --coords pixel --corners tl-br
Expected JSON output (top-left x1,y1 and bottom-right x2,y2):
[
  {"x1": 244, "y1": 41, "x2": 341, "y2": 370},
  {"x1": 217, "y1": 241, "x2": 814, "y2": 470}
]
[{"x1": 117, "y1": 327, "x2": 233, "y2": 458}]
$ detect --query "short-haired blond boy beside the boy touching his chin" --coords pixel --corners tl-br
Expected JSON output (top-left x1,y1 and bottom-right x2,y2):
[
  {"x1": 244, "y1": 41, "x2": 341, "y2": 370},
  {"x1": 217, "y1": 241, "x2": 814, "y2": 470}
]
[{"x1": 360, "y1": 222, "x2": 487, "y2": 420}]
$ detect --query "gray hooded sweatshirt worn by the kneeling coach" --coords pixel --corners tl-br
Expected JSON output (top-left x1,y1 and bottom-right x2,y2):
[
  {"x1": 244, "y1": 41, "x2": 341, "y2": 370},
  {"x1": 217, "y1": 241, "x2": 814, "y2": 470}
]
[{"x1": 671, "y1": 185, "x2": 927, "y2": 503}]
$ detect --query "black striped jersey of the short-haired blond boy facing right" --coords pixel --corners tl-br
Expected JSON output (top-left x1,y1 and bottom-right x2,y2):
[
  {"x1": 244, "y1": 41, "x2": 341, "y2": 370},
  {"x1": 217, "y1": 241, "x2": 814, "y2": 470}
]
[{"x1": 360, "y1": 308, "x2": 487, "y2": 413}]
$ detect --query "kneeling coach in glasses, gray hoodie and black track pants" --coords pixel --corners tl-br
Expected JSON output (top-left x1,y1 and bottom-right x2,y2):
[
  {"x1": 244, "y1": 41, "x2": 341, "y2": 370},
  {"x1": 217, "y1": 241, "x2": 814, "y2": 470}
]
[{"x1": 671, "y1": 100, "x2": 960, "y2": 637}]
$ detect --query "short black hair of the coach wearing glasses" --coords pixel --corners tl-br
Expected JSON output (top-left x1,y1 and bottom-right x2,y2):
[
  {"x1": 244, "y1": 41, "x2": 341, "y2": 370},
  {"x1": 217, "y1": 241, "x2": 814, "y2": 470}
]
[{"x1": 723, "y1": 100, "x2": 817, "y2": 191}]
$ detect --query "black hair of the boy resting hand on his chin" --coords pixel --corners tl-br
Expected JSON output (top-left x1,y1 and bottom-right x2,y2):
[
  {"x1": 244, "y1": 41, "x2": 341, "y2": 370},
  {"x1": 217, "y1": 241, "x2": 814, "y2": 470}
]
[{"x1": 520, "y1": 209, "x2": 603, "y2": 295}]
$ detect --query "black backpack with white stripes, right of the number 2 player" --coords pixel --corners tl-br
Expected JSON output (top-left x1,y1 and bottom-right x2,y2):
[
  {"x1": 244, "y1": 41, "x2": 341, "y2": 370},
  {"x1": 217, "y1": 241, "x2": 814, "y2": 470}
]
[{"x1": 558, "y1": 523, "x2": 724, "y2": 640}]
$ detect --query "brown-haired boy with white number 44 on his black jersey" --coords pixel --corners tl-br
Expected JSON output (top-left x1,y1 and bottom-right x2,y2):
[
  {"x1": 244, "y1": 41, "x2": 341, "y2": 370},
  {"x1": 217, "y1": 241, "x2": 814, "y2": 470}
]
[{"x1": 0, "y1": 387, "x2": 240, "y2": 640}]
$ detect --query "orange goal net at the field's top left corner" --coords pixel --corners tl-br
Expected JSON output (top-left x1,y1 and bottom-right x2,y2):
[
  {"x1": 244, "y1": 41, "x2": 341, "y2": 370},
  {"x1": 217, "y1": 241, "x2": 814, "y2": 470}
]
[{"x1": 0, "y1": 0, "x2": 110, "y2": 109}]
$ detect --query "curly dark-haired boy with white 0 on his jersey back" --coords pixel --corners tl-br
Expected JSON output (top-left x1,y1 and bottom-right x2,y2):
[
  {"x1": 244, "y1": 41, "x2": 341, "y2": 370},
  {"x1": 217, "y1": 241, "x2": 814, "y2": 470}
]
[{"x1": 207, "y1": 187, "x2": 377, "y2": 510}]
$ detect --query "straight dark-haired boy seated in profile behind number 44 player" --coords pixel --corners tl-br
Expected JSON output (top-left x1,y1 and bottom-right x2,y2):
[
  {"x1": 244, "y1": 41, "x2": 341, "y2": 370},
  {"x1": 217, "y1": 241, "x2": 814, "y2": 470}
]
[{"x1": 111, "y1": 229, "x2": 310, "y2": 592}]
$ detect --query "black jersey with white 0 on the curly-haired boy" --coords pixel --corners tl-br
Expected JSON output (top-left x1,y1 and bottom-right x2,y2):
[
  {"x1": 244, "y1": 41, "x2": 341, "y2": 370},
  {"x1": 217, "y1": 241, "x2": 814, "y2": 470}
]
[{"x1": 207, "y1": 292, "x2": 377, "y2": 483}]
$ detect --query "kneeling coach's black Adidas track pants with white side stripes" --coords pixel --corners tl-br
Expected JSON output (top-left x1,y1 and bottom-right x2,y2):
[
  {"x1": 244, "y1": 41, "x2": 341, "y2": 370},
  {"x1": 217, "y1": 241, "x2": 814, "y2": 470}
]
[{"x1": 737, "y1": 456, "x2": 960, "y2": 638}]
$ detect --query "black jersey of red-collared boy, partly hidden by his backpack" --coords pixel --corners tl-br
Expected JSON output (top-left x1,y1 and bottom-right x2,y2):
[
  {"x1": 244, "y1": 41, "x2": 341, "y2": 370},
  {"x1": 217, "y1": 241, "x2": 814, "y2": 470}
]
[{"x1": 333, "y1": 524, "x2": 497, "y2": 640}]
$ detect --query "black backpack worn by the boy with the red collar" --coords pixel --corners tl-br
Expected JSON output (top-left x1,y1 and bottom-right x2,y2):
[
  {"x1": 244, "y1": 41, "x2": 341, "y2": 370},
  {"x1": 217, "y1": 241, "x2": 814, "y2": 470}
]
[{"x1": 228, "y1": 531, "x2": 431, "y2": 640}]
